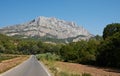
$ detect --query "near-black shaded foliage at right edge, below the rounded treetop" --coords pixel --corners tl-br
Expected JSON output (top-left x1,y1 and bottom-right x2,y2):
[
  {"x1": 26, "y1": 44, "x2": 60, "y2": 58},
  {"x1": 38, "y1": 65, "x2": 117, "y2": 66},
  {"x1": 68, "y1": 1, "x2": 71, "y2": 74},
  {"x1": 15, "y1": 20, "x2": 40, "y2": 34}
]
[{"x1": 97, "y1": 32, "x2": 120, "y2": 68}]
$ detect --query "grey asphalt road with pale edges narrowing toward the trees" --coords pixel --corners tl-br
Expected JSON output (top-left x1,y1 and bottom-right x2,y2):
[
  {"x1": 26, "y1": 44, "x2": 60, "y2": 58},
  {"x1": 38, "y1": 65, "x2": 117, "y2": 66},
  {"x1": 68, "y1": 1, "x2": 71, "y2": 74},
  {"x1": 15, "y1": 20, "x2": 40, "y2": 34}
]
[{"x1": 0, "y1": 55, "x2": 51, "y2": 76}]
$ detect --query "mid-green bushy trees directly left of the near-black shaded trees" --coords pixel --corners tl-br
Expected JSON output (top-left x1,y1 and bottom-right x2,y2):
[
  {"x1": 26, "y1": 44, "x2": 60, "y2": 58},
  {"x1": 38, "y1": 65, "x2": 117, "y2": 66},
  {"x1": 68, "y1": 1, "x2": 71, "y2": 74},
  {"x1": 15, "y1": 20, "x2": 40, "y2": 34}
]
[{"x1": 60, "y1": 39, "x2": 100, "y2": 64}]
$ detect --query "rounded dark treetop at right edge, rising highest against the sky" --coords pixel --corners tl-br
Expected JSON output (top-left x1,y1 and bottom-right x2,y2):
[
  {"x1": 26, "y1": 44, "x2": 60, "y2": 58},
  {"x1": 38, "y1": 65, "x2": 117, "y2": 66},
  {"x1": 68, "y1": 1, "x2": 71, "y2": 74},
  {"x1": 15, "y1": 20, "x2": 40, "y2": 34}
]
[{"x1": 103, "y1": 23, "x2": 120, "y2": 39}]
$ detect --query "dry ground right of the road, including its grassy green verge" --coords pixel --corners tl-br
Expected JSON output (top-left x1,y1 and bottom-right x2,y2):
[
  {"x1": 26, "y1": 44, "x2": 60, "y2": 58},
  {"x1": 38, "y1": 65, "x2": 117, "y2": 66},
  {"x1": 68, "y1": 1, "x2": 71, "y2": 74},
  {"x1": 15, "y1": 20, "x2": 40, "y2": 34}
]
[{"x1": 38, "y1": 55, "x2": 120, "y2": 76}]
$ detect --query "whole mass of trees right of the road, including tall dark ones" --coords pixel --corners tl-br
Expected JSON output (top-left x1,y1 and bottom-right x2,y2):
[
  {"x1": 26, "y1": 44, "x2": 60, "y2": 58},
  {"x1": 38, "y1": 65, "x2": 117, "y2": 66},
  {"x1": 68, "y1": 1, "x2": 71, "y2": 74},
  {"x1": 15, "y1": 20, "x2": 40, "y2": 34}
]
[{"x1": 60, "y1": 23, "x2": 120, "y2": 68}]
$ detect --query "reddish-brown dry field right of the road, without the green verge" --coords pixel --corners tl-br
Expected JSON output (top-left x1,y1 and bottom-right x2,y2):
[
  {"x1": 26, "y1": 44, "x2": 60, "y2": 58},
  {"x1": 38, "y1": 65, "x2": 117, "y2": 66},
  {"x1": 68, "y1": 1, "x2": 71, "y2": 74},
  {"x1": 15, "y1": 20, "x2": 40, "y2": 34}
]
[{"x1": 55, "y1": 62, "x2": 120, "y2": 76}]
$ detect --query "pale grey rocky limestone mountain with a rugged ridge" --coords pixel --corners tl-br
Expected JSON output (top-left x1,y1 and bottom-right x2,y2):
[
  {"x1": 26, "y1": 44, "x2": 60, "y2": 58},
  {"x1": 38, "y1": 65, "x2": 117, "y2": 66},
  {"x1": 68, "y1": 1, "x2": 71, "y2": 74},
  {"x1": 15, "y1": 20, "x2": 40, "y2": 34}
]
[{"x1": 0, "y1": 16, "x2": 93, "y2": 41}]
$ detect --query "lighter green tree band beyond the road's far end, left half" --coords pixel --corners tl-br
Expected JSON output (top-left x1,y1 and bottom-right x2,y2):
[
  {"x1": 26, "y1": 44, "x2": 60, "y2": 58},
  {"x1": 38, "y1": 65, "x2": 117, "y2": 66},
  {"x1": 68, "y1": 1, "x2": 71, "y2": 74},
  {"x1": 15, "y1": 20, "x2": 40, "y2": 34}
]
[{"x1": 0, "y1": 34, "x2": 59, "y2": 55}]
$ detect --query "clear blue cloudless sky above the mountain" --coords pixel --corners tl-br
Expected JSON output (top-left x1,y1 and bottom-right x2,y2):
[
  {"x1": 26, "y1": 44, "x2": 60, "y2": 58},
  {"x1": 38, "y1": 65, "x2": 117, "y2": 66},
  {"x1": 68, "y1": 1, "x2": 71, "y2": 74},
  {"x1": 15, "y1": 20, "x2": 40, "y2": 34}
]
[{"x1": 0, "y1": 0, "x2": 120, "y2": 35}]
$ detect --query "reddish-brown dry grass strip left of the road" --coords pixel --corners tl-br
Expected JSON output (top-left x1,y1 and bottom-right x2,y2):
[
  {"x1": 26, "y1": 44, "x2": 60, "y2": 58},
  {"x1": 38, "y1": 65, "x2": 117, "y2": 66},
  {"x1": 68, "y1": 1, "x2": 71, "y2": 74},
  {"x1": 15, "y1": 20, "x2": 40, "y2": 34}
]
[{"x1": 0, "y1": 56, "x2": 29, "y2": 73}]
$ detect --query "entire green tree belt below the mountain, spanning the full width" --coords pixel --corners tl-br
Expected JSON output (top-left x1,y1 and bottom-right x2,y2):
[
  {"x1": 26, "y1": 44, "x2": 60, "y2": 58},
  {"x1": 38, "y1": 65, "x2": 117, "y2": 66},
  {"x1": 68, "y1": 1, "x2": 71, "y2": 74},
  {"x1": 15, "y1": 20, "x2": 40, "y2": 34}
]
[{"x1": 0, "y1": 23, "x2": 120, "y2": 68}]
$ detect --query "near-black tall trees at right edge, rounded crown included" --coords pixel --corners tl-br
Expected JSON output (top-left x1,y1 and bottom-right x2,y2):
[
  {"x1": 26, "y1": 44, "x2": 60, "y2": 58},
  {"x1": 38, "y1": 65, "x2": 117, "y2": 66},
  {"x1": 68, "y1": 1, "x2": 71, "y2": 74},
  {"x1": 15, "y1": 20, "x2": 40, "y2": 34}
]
[{"x1": 96, "y1": 23, "x2": 120, "y2": 68}]
